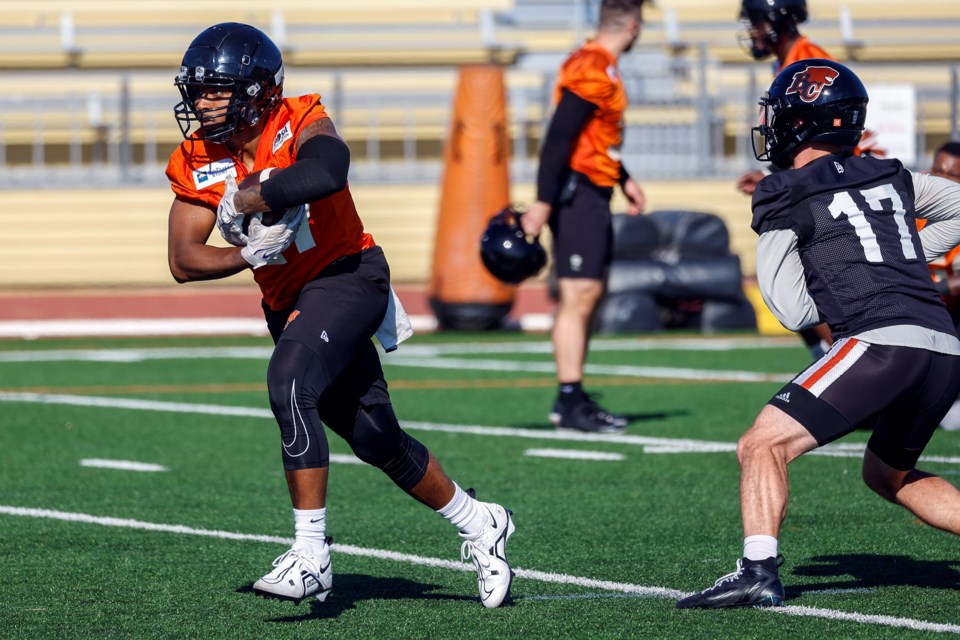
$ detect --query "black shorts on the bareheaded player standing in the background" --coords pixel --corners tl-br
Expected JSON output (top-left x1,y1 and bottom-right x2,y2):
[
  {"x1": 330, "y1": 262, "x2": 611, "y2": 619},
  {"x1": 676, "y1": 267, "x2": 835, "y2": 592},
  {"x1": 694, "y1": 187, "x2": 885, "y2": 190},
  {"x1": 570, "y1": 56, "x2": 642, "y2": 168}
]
[{"x1": 550, "y1": 173, "x2": 613, "y2": 280}]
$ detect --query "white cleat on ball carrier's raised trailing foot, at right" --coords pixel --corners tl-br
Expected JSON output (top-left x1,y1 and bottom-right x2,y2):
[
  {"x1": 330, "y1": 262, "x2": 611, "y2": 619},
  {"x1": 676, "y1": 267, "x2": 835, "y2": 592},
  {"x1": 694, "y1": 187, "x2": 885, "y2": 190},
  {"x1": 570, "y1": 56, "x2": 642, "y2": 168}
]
[{"x1": 460, "y1": 502, "x2": 516, "y2": 609}]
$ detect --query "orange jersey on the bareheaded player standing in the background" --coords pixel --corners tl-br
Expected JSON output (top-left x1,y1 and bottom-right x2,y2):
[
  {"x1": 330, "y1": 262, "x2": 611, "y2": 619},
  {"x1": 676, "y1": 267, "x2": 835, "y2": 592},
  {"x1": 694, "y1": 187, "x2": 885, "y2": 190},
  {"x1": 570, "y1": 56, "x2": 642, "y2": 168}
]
[{"x1": 554, "y1": 42, "x2": 627, "y2": 187}]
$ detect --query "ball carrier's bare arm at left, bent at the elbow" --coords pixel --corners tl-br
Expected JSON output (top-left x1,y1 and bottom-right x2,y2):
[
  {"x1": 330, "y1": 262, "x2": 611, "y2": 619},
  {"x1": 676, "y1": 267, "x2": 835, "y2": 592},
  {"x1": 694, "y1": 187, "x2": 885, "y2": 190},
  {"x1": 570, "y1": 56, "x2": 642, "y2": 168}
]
[{"x1": 167, "y1": 198, "x2": 250, "y2": 282}]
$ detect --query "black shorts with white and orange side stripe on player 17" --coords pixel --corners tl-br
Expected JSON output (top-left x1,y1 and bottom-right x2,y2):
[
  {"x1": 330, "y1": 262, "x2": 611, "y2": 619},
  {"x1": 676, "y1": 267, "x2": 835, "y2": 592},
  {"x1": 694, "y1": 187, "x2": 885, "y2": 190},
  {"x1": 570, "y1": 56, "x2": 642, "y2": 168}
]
[{"x1": 768, "y1": 338, "x2": 960, "y2": 471}]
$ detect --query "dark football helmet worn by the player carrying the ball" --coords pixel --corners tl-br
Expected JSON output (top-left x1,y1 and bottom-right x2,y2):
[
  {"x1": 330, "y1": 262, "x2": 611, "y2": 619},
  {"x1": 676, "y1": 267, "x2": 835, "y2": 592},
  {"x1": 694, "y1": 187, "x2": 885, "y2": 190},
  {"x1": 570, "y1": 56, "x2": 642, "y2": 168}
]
[{"x1": 173, "y1": 22, "x2": 283, "y2": 142}]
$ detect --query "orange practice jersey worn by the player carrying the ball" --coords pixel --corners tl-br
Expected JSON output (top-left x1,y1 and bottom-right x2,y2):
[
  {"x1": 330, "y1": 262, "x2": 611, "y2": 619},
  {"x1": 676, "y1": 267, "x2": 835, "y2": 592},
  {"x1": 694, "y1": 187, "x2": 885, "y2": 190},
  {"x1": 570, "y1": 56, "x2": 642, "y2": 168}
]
[{"x1": 167, "y1": 94, "x2": 375, "y2": 310}]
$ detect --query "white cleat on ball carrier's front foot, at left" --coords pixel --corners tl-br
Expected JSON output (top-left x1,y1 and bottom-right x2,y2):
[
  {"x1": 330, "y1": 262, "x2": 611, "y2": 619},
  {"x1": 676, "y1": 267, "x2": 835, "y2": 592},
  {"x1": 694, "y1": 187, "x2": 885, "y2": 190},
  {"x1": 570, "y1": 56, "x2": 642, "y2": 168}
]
[{"x1": 253, "y1": 539, "x2": 333, "y2": 604}]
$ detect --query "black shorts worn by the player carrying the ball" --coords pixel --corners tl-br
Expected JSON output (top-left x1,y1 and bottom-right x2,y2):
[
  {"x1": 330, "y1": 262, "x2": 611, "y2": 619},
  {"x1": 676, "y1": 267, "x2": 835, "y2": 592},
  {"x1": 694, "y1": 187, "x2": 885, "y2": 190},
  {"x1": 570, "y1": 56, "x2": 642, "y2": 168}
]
[{"x1": 263, "y1": 247, "x2": 390, "y2": 408}]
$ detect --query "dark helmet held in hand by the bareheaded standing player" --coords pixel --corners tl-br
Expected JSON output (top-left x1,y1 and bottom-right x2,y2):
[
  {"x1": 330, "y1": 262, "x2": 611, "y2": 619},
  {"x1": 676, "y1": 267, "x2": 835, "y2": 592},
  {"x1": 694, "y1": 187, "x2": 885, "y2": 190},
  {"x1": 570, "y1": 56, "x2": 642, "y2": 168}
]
[{"x1": 480, "y1": 206, "x2": 547, "y2": 284}]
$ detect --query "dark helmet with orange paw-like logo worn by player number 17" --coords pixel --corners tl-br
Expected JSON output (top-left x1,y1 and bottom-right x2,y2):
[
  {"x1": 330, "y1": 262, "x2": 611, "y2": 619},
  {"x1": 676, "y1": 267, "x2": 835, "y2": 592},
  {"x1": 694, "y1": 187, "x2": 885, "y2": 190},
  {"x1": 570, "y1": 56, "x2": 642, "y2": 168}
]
[{"x1": 753, "y1": 58, "x2": 868, "y2": 168}]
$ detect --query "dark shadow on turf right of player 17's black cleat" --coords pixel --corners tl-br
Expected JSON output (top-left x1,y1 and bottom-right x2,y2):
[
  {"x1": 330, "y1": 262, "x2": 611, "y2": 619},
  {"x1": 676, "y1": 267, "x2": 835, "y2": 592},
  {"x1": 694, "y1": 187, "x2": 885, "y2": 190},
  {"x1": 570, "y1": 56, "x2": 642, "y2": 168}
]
[{"x1": 786, "y1": 554, "x2": 960, "y2": 600}]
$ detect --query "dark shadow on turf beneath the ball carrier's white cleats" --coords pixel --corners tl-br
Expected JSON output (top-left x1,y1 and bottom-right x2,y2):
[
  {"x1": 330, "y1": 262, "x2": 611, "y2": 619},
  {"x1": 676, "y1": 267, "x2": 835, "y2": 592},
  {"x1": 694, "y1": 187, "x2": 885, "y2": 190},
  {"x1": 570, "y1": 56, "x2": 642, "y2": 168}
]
[{"x1": 237, "y1": 573, "x2": 480, "y2": 622}]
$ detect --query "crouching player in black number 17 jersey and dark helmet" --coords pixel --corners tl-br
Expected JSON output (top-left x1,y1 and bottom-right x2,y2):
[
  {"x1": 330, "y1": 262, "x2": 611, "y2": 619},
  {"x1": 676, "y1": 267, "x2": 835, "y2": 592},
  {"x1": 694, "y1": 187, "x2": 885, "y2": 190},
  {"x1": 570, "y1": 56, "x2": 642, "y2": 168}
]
[{"x1": 676, "y1": 59, "x2": 960, "y2": 609}]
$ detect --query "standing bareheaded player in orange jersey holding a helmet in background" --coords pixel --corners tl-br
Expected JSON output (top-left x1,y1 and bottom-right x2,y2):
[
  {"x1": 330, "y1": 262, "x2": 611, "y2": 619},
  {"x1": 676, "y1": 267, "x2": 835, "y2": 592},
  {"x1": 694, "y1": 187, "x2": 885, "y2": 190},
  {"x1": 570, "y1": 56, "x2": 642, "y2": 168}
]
[{"x1": 520, "y1": 0, "x2": 645, "y2": 433}]
